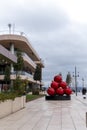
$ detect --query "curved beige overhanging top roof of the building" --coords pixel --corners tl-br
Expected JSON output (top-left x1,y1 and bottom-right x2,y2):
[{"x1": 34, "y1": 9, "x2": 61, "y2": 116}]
[{"x1": 0, "y1": 34, "x2": 40, "y2": 61}]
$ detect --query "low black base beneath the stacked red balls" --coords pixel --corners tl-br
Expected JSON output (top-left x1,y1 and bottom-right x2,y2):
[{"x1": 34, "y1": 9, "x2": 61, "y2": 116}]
[{"x1": 45, "y1": 95, "x2": 71, "y2": 100}]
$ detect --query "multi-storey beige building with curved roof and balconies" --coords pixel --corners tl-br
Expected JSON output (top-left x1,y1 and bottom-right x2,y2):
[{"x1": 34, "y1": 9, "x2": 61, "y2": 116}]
[{"x1": 0, "y1": 33, "x2": 44, "y2": 89}]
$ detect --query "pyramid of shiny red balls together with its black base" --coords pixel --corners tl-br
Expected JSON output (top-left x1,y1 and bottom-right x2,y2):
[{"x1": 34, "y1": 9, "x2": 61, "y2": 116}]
[{"x1": 46, "y1": 75, "x2": 72, "y2": 100}]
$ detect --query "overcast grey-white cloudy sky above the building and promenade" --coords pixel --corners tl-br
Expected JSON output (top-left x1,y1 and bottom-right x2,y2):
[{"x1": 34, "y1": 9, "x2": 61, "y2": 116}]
[{"x1": 0, "y1": 0, "x2": 87, "y2": 87}]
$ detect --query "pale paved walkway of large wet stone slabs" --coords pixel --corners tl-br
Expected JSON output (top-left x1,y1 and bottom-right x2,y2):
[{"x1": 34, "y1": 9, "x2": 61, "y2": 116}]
[{"x1": 0, "y1": 94, "x2": 87, "y2": 130}]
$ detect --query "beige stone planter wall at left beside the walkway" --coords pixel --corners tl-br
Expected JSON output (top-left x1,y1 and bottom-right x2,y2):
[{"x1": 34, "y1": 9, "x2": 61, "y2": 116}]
[{"x1": 0, "y1": 96, "x2": 26, "y2": 118}]
